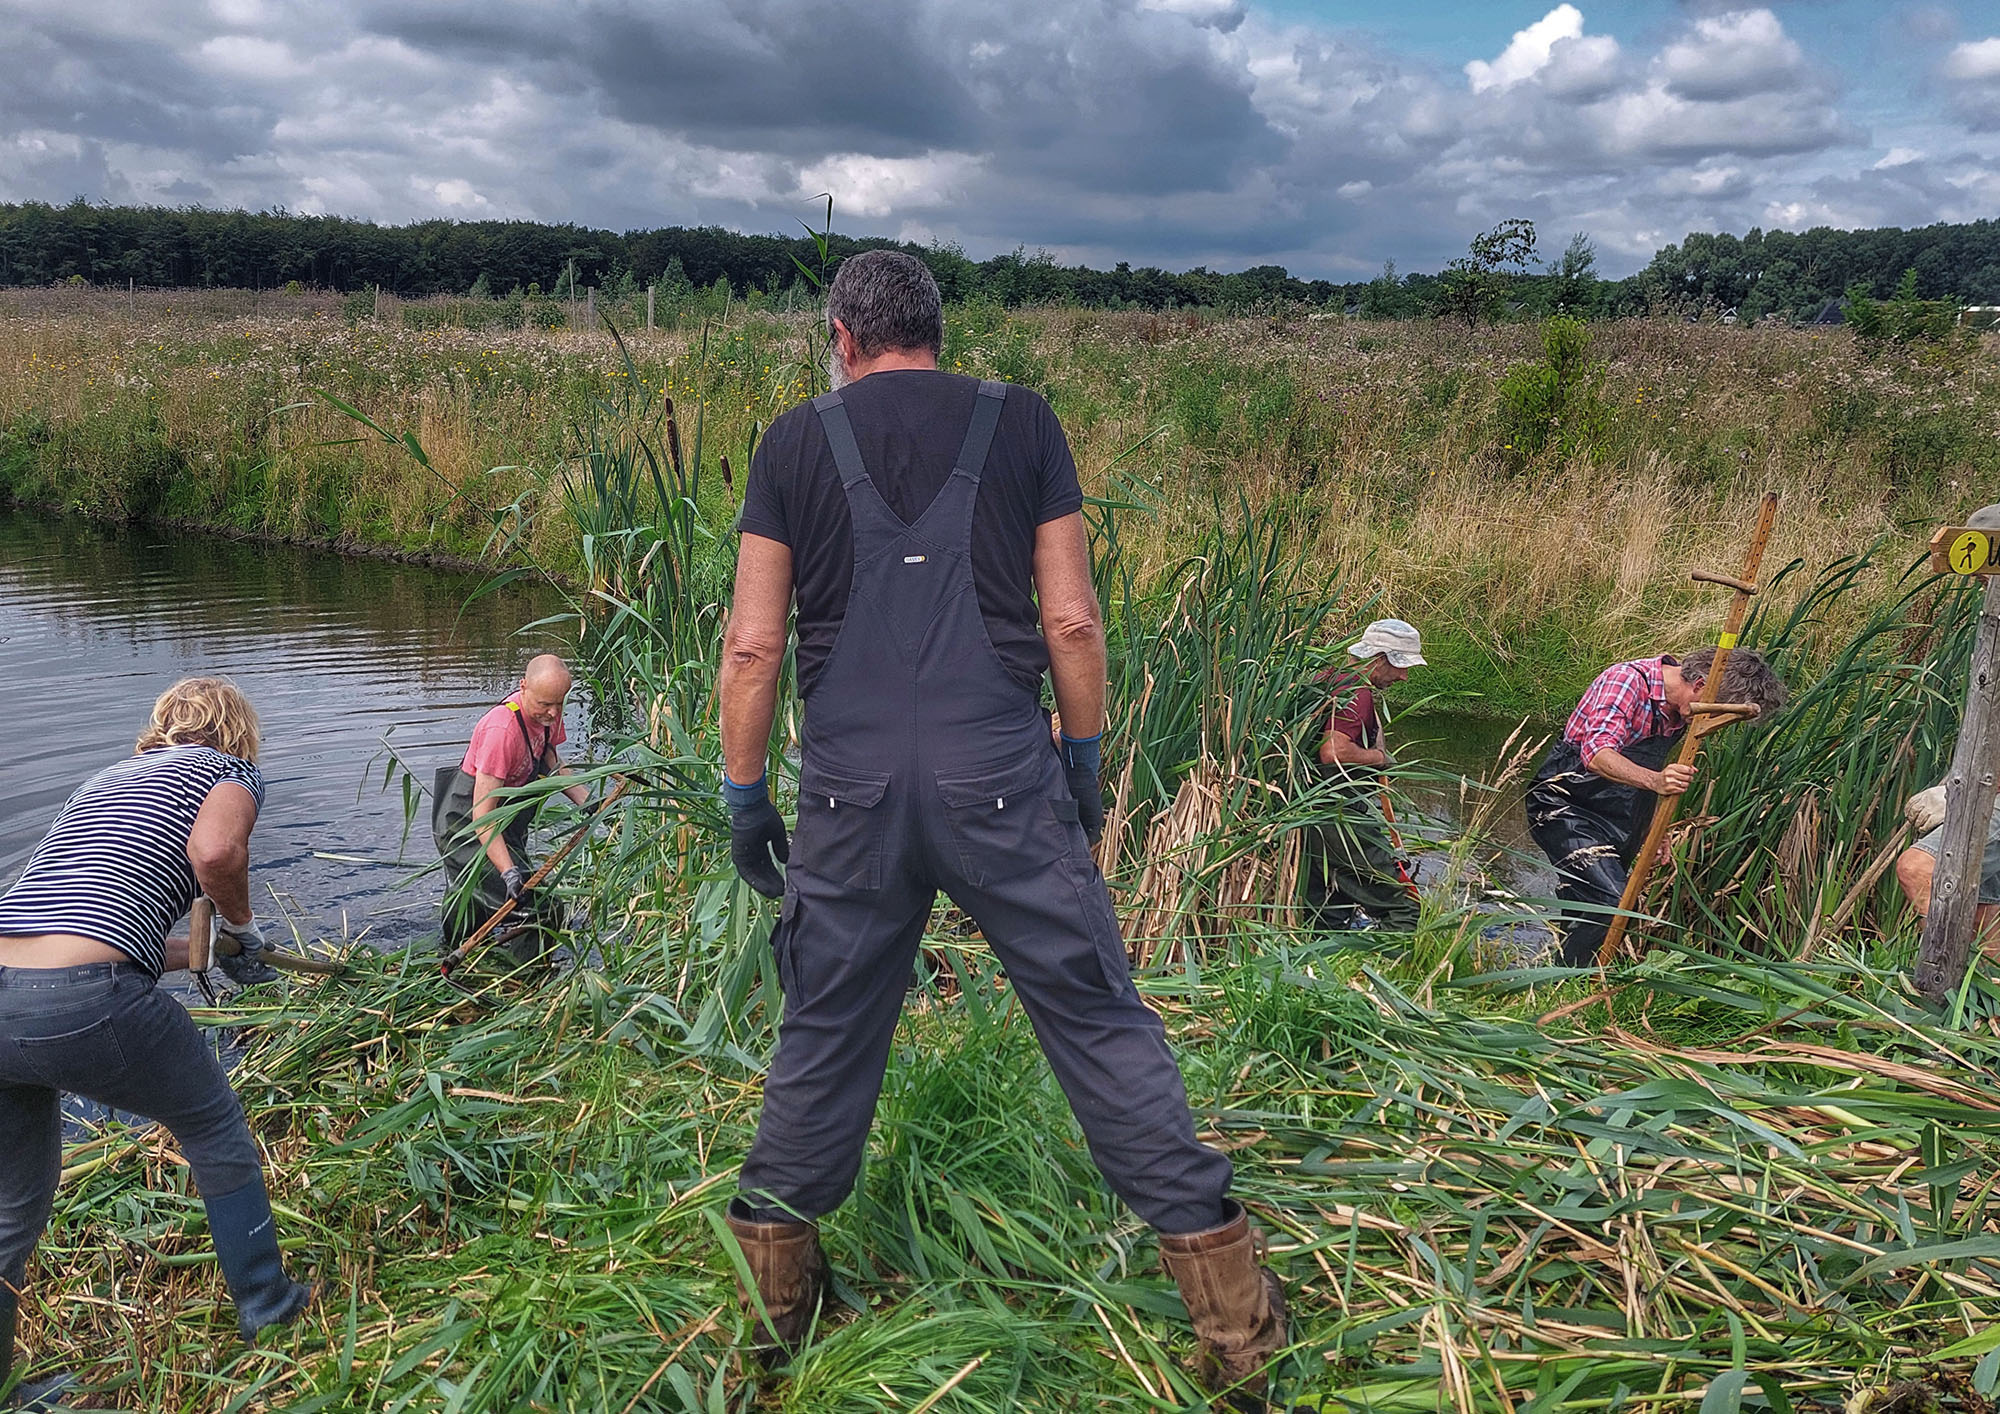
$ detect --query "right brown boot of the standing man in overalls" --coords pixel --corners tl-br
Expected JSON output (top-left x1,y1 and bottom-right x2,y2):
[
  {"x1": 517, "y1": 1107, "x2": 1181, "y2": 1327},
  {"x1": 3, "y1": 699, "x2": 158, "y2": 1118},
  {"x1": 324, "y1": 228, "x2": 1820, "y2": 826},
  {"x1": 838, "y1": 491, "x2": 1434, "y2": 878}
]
[{"x1": 1160, "y1": 1198, "x2": 1286, "y2": 1410}]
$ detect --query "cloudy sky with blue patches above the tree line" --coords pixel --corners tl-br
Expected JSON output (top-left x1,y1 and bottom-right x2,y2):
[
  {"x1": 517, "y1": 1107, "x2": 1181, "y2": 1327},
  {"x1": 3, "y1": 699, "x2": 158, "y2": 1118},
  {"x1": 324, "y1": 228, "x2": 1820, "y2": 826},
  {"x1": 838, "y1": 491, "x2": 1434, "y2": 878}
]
[{"x1": 0, "y1": 0, "x2": 2000, "y2": 280}]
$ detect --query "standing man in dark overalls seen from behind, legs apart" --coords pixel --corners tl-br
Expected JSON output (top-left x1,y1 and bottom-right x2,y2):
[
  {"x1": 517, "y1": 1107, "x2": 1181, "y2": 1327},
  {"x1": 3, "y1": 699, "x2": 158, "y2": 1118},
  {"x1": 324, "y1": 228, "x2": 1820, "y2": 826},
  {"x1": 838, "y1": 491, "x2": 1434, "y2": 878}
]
[{"x1": 718, "y1": 250, "x2": 1284, "y2": 1396}]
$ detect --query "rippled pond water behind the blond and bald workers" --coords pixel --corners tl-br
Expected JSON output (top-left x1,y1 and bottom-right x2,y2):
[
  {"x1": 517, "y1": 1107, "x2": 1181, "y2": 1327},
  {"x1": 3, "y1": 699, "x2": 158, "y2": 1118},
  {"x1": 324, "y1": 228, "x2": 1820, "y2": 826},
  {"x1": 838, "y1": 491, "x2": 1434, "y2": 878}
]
[{"x1": 0, "y1": 512, "x2": 582, "y2": 948}]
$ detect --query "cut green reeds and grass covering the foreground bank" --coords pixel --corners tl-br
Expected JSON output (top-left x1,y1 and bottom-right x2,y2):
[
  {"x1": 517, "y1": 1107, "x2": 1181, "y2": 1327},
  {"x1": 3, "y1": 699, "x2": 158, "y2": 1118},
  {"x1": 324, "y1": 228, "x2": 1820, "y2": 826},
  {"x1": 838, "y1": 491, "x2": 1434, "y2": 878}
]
[{"x1": 28, "y1": 936, "x2": 2000, "y2": 1414}]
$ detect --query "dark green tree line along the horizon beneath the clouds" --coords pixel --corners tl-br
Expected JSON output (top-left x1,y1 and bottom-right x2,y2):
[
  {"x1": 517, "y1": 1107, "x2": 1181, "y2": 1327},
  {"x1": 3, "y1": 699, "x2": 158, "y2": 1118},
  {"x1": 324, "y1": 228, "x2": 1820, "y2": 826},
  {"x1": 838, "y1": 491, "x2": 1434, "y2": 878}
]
[{"x1": 0, "y1": 200, "x2": 2000, "y2": 322}]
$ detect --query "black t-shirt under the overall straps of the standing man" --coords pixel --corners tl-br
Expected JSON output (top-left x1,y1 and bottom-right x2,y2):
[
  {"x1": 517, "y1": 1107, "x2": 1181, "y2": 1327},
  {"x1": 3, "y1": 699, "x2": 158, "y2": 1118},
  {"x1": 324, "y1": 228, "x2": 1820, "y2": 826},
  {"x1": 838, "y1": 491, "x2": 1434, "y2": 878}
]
[{"x1": 738, "y1": 368, "x2": 1084, "y2": 692}]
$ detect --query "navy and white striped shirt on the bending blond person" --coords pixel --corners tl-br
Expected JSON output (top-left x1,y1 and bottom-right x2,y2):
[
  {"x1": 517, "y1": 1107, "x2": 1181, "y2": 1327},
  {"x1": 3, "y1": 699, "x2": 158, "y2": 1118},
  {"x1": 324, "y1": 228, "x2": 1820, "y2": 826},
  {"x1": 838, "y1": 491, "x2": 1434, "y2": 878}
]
[{"x1": 0, "y1": 746, "x2": 264, "y2": 976}]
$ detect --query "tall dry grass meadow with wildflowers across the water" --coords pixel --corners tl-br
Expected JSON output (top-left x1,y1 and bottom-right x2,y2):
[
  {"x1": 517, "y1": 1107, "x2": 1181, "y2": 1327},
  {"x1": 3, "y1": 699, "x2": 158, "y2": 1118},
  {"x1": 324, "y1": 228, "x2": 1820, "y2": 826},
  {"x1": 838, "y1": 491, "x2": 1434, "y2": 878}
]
[{"x1": 0, "y1": 292, "x2": 2000, "y2": 716}]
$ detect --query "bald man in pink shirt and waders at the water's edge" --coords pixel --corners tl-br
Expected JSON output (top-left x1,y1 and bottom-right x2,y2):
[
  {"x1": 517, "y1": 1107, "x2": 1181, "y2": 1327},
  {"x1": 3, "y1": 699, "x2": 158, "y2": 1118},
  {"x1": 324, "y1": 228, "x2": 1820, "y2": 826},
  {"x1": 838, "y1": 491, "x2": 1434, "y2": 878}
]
[{"x1": 430, "y1": 654, "x2": 588, "y2": 964}]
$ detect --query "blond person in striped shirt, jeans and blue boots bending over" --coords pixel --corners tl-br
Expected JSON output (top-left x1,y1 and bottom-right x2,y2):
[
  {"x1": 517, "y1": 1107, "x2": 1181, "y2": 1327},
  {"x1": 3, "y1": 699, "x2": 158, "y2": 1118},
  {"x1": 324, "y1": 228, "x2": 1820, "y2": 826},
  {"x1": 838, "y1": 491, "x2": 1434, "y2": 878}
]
[{"x1": 0, "y1": 678, "x2": 312, "y2": 1408}]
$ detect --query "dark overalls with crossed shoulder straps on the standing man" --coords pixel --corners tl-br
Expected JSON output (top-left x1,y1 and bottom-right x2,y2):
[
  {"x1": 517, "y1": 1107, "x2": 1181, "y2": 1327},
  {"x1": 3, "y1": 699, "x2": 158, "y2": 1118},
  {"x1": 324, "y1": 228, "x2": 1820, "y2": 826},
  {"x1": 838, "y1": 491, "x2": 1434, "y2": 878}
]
[{"x1": 742, "y1": 382, "x2": 1230, "y2": 1232}]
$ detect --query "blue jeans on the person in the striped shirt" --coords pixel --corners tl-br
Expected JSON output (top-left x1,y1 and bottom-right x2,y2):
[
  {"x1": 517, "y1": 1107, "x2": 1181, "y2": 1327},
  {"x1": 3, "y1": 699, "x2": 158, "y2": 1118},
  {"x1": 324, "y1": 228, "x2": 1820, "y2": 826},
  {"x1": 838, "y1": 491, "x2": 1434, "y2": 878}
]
[{"x1": 0, "y1": 962, "x2": 262, "y2": 1290}]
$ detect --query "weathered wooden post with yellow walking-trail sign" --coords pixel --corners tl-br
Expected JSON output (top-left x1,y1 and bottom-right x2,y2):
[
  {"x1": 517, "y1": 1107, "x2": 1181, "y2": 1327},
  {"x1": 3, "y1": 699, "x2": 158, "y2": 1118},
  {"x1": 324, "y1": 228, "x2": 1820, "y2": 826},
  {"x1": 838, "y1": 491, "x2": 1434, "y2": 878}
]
[{"x1": 1916, "y1": 506, "x2": 2000, "y2": 1004}]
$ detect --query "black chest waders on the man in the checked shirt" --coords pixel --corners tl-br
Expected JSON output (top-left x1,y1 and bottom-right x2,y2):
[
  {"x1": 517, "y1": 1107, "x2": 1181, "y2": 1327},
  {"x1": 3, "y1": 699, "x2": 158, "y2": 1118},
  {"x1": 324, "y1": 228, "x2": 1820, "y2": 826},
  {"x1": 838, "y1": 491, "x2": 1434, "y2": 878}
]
[{"x1": 1526, "y1": 732, "x2": 1680, "y2": 968}]
